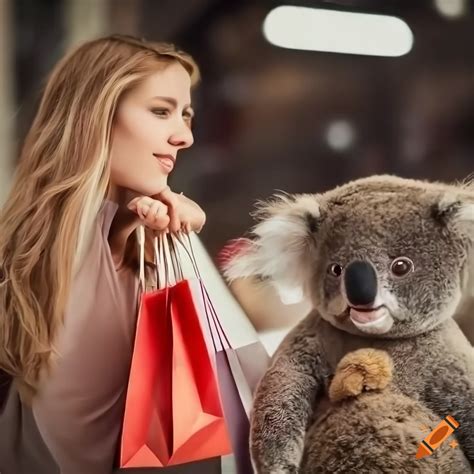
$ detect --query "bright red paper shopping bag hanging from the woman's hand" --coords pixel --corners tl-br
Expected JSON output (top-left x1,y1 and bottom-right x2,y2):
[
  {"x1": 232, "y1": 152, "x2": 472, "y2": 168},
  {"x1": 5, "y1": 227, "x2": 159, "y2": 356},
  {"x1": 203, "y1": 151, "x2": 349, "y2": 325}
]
[{"x1": 119, "y1": 280, "x2": 232, "y2": 467}]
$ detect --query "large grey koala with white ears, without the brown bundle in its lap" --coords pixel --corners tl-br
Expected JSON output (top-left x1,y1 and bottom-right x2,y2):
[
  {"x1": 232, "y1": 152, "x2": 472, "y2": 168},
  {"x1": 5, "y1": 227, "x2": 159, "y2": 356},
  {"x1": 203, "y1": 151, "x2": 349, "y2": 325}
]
[{"x1": 226, "y1": 176, "x2": 474, "y2": 474}]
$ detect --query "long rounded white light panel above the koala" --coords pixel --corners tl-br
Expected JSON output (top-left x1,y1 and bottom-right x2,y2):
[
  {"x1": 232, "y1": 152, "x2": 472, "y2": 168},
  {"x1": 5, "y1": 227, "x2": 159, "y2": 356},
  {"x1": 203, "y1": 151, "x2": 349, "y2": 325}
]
[{"x1": 263, "y1": 6, "x2": 413, "y2": 56}]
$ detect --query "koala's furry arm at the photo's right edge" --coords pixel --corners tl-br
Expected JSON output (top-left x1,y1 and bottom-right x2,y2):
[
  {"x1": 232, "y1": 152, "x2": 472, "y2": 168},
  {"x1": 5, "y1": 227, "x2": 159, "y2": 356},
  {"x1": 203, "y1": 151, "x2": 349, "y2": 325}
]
[{"x1": 424, "y1": 351, "x2": 474, "y2": 465}]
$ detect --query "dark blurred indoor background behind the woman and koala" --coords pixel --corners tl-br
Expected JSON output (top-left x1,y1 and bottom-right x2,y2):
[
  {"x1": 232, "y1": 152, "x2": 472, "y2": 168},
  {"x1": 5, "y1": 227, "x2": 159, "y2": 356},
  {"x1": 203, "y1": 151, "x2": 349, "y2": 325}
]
[{"x1": 0, "y1": 0, "x2": 474, "y2": 340}]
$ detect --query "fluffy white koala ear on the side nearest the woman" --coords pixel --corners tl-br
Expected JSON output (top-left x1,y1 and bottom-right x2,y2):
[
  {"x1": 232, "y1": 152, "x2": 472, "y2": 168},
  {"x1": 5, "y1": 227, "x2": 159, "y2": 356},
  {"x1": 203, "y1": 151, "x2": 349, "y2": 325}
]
[{"x1": 224, "y1": 194, "x2": 321, "y2": 304}]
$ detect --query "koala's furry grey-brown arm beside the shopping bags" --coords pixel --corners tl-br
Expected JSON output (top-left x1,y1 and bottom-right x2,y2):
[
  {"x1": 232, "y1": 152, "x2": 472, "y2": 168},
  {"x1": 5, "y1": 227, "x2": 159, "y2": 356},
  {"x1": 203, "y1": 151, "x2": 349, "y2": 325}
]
[{"x1": 250, "y1": 314, "x2": 328, "y2": 474}]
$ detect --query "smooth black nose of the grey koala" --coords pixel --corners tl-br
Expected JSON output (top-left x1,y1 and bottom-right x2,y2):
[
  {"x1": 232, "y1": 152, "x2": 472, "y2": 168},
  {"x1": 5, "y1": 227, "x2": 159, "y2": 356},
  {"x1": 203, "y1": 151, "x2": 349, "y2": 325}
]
[{"x1": 344, "y1": 261, "x2": 377, "y2": 306}]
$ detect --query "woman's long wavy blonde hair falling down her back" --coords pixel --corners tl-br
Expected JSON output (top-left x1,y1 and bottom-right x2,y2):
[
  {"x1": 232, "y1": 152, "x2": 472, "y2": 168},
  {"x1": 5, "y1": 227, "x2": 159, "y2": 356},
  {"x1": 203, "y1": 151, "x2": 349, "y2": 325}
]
[{"x1": 0, "y1": 35, "x2": 199, "y2": 398}]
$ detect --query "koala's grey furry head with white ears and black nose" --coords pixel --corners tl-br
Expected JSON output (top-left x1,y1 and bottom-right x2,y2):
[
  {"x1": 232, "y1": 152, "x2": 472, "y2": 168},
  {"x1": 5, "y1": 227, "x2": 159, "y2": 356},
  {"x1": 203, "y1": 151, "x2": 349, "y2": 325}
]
[{"x1": 226, "y1": 176, "x2": 474, "y2": 338}]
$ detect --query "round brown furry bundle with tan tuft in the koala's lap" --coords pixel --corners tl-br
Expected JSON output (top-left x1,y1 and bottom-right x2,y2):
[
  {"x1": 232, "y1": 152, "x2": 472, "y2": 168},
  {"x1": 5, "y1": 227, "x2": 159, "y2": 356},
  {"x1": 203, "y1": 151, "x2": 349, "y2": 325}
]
[{"x1": 300, "y1": 349, "x2": 471, "y2": 474}]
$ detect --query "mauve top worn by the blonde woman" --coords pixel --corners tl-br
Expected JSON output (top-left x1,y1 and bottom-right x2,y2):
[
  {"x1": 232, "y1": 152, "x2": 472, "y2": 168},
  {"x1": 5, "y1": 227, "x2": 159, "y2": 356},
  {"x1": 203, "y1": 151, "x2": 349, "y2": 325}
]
[{"x1": 0, "y1": 201, "x2": 138, "y2": 474}]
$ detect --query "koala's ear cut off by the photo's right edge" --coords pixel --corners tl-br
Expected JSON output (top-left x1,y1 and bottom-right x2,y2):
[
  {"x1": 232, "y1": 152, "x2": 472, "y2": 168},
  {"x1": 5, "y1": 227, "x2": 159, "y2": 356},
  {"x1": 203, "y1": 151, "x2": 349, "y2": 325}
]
[{"x1": 431, "y1": 194, "x2": 474, "y2": 242}]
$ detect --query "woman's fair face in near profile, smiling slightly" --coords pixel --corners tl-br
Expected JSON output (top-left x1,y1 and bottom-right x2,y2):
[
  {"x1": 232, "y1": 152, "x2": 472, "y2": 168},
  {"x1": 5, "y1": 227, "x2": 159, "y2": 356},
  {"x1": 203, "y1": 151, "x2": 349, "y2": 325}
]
[{"x1": 111, "y1": 62, "x2": 193, "y2": 196}]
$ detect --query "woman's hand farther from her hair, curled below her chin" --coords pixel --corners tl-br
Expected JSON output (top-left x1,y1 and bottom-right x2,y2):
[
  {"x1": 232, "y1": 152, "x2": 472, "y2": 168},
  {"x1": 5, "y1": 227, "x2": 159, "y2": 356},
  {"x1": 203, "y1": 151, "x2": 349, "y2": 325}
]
[{"x1": 153, "y1": 188, "x2": 206, "y2": 233}]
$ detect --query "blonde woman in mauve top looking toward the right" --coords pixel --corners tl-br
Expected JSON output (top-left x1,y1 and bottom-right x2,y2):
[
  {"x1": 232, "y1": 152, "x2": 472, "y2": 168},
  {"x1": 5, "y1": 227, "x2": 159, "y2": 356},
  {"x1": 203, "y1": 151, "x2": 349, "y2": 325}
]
[{"x1": 0, "y1": 36, "x2": 205, "y2": 474}]
